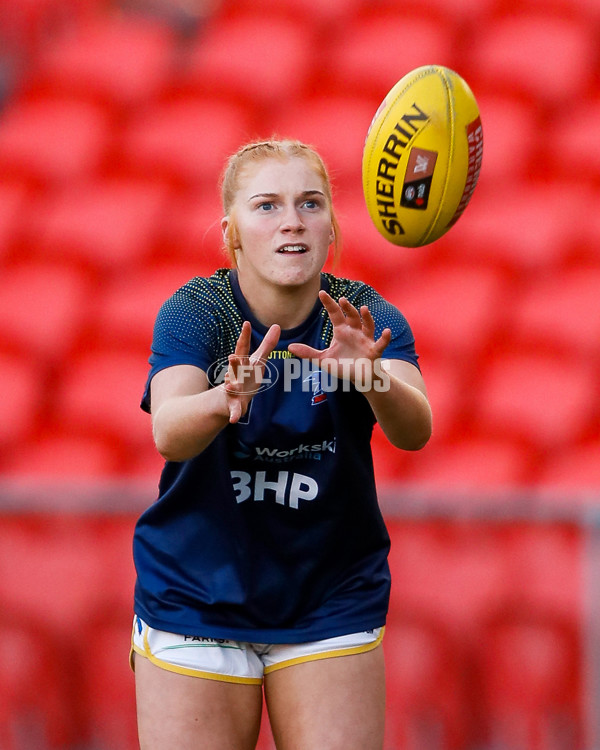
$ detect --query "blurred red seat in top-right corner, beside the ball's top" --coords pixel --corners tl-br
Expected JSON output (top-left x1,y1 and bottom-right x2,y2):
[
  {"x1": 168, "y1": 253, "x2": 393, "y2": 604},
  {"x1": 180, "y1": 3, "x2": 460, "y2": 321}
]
[{"x1": 465, "y1": 8, "x2": 596, "y2": 107}]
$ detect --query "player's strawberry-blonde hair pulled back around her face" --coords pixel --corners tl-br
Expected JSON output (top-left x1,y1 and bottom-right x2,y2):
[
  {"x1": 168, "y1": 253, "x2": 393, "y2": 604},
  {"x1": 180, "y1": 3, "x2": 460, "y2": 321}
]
[{"x1": 221, "y1": 138, "x2": 341, "y2": 266}]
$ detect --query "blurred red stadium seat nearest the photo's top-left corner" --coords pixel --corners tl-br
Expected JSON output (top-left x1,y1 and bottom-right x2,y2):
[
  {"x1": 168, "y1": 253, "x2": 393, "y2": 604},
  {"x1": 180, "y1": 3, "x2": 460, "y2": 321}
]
[{"x1": 30, "y1": 14, "x2": 175, "y2": 106}]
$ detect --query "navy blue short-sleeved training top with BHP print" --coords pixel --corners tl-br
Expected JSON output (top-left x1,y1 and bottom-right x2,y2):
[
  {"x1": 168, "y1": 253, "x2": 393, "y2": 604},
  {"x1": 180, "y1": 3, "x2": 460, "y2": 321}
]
[{"x1": 134, "y1": 269, "x2": 417, "y2": 643}]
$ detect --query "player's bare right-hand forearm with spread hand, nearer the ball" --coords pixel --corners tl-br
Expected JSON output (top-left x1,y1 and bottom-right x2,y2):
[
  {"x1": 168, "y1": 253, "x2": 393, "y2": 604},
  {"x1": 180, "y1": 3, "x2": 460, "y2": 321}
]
[{"x1": 288, "y1": 291, "x2": 431, "y2": 450}]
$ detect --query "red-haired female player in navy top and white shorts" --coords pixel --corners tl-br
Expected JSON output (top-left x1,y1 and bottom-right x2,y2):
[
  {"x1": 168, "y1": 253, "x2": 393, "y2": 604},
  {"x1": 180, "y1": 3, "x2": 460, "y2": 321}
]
[{"x1": 132, "y1": 140, "x2": 431, "y2": 750}]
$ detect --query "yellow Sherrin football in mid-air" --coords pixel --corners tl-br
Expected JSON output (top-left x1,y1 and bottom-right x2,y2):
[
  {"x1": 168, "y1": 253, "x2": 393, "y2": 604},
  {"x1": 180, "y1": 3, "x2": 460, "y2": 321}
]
[{"x1": 362, "y1": 65, "x2": 483, "y2": 247}]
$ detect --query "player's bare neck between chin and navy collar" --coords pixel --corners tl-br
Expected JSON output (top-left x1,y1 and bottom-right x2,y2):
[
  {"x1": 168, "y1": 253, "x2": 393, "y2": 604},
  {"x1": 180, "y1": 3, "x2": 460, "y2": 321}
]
[{"x1": 238, "y1": 274, "x2": 321, "y2": 329}]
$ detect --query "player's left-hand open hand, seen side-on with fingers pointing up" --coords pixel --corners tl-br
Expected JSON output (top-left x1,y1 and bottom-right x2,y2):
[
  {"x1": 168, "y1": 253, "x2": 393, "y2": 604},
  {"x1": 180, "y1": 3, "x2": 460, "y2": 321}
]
[{"x1": 223, "y1": 320, "x2": 281, "y2": 424}]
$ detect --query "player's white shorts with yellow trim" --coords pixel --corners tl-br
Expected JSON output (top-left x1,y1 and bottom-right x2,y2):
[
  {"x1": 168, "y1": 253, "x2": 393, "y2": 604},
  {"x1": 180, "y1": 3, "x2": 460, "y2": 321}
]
[{"x1": 131, "y1": 616, "x2": 384, "y2": 685}]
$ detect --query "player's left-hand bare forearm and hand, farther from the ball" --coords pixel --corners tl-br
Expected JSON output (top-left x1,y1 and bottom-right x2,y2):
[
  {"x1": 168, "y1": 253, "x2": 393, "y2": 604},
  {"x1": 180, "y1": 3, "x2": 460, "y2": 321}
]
[{"x1": 151, "y1": 322, "x2": 279, "y2": 461}]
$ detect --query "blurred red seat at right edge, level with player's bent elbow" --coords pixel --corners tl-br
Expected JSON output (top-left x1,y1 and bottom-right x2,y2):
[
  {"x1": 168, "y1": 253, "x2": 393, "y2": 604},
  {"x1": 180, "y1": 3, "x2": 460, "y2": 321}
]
[{"x1": 474, "y1": 352, "x2": 597, "y2": 450}]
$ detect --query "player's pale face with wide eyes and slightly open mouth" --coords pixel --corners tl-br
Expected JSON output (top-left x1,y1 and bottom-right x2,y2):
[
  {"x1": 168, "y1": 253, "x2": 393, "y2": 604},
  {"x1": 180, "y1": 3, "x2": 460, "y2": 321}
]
[{"x1": 222, "y1": 157, "x2": 334, "y2": 293}]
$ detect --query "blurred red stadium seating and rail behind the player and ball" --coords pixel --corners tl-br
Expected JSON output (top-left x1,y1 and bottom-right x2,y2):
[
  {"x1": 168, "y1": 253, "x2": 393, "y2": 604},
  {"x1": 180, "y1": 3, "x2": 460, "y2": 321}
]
[{"x1": 0, "y1": 0, "x2": 600, "y2": 750}]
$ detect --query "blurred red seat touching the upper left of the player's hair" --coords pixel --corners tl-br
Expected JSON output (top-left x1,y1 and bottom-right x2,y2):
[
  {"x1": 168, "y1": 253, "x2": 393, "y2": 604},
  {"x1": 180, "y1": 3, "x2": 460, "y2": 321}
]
[{"x1": 119, "y1": 97, "x2": 256, "y2": 190}]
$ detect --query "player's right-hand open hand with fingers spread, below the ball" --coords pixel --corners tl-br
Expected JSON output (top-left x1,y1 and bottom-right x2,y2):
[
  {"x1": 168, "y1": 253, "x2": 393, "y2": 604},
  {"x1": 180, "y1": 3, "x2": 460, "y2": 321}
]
[{"x1": 288, "y1": 290, "x2": 392, "y2": 383}]
